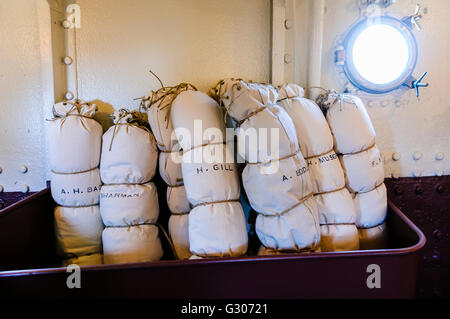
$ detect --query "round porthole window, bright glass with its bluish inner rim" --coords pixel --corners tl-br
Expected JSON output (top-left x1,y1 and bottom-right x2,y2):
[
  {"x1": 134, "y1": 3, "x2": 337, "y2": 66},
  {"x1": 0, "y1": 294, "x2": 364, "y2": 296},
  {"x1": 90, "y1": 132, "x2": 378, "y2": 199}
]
[{"x1": 344, "y1": 16, "x2": 417, "y2": 93}]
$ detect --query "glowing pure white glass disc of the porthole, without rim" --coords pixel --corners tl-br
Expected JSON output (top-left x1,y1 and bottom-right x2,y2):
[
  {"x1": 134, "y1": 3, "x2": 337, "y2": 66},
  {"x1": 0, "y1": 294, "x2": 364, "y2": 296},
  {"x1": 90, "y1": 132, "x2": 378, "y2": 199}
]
[{"x1": 351, "y1": 24, "x2": 410, "y2": 85}]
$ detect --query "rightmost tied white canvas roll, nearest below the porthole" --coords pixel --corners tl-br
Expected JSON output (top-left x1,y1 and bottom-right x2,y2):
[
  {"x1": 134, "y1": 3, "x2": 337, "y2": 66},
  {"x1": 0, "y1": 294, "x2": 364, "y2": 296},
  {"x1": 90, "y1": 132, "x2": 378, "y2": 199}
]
[{"x1": 327, "y1": 94, "x2": 387, "y2": 249}]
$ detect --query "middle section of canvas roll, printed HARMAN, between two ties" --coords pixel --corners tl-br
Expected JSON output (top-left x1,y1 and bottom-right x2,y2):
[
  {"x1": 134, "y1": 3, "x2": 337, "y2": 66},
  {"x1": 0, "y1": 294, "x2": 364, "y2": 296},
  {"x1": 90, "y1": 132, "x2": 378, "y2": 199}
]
[{"x1": 100, "y1": 183, "x2": 159, "y2": 226}]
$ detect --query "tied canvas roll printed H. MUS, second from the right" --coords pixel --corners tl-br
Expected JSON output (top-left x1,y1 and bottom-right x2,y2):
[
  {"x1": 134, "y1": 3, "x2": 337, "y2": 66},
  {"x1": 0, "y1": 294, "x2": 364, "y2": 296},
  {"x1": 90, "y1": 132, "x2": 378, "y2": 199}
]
[{"x1": 278, "y1": 84, "x2": 359, "y2": 251}]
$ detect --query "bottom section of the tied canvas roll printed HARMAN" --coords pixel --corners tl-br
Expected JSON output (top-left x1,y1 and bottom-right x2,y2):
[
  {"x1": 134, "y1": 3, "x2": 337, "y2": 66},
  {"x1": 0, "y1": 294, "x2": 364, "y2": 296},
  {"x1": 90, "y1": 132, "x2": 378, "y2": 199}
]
[{"x1": 102, "y1": 225, "x2": 163, "y2": 264}]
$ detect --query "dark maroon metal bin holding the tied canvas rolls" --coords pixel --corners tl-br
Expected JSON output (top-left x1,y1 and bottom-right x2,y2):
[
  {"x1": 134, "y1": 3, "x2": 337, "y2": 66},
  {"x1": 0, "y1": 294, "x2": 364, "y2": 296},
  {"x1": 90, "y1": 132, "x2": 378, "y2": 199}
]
[{"x1": 0, "y1": 189, "x2": 425, "y2": 299}]
